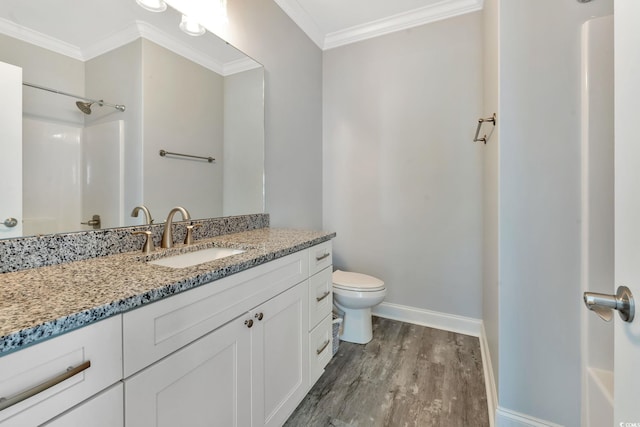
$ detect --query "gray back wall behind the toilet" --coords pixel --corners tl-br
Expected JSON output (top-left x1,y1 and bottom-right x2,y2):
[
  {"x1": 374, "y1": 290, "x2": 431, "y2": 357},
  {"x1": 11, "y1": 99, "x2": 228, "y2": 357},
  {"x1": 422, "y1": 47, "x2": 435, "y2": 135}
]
[{"x1": 323, "y1": 12, "x2": 482, "y2": 318}]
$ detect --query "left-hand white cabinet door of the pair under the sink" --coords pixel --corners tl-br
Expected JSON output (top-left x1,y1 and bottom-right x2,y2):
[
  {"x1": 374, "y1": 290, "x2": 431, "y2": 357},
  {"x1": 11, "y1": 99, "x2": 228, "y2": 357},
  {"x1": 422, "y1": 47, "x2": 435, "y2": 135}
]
[{"x1": 124, "y1": 316, "x2": 251, "y2": 427}]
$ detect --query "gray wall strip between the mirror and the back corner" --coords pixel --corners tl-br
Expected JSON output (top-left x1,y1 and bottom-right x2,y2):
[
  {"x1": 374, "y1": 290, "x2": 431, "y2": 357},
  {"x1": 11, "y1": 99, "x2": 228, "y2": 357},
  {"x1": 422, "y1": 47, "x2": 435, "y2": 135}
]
[{"x1": 222, "y1": 0, "x2": 322, "y2": 228}]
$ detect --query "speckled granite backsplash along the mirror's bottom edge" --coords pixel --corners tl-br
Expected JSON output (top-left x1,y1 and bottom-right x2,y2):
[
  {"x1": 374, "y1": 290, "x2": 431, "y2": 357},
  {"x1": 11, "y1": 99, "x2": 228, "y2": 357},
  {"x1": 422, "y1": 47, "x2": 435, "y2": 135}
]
[{"x1": 0, "y1": 214, "x2": 269, "y2": 273}]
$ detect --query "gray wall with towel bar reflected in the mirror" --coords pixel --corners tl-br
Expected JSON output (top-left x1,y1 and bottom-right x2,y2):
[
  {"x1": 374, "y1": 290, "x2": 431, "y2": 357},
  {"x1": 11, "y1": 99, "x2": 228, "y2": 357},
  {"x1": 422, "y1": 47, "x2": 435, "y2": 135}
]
[{"x1": 141, "y1": 39, "x2": 224, "y2": 221}]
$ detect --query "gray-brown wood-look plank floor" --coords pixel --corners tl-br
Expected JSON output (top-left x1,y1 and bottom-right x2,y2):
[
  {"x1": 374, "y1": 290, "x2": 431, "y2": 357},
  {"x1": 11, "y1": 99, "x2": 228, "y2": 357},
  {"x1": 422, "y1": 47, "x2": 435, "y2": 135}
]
[{"x1": 285, "y1": 317, "x2": 489, "y2": 427}]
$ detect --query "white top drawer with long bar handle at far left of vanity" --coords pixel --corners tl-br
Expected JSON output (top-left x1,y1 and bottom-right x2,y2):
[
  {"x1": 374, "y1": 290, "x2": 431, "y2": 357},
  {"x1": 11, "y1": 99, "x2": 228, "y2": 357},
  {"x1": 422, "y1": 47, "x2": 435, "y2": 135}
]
[{"x1": 0, "y1": 316, "x2": 122, "y2": 427}]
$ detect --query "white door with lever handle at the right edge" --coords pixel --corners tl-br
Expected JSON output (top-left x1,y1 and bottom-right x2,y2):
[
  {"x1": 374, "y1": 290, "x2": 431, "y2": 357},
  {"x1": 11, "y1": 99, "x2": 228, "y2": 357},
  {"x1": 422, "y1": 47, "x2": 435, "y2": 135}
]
[{"x1": 614, "y1": 0, "x2": 640, "y2": 427}]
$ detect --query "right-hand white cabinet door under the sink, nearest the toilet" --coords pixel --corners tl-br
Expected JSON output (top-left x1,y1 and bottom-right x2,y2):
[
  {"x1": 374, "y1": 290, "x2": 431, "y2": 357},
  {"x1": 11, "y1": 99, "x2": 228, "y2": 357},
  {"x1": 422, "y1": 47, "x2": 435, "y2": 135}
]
[{"x1": 251, "y1": 281, "x2": 309, "y2": 427}]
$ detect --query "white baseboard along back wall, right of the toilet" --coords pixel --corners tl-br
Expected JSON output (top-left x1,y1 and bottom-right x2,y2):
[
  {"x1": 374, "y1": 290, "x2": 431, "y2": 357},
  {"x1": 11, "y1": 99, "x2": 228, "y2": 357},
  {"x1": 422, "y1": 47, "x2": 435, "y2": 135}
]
[{"x1": 371, "y1": 302, "x2": 482, "y2": 337}]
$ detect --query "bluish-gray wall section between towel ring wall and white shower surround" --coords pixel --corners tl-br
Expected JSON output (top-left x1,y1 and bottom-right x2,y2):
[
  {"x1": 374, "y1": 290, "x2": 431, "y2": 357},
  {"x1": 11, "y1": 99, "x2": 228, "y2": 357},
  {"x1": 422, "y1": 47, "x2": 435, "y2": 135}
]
[{"x1": 487, "y1": 0, "x2": 613, "y2": 426}]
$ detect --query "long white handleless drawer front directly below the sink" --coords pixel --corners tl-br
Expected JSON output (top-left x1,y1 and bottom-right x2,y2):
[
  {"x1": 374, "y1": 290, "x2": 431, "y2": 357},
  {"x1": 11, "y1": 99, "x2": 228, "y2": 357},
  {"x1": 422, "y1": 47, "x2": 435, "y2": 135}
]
[{"x1": 123, "y1": 250, "x2": 309, "y2": 378}]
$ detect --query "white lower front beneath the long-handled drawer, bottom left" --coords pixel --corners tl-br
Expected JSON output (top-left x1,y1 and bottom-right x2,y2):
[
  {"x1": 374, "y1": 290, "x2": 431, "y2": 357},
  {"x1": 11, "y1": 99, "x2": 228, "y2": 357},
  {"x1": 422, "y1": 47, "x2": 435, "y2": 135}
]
[{"x1": 42, "y1": 382, "x2": 124, "y2": 427}]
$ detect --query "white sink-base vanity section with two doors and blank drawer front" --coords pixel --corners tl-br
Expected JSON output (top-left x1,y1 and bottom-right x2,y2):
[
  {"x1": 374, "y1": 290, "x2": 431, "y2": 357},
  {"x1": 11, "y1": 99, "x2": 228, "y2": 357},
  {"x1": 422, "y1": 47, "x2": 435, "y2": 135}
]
[{"x1": 124, "y1": 250, "x2": 309, "y2": 427}]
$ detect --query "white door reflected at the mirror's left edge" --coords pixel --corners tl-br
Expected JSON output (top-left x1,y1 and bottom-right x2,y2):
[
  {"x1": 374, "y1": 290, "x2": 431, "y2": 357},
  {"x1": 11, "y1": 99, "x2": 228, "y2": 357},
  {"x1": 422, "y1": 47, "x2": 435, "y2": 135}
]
[{"x1": 0, "y1": 62, "x2": 22, "y2": 239}]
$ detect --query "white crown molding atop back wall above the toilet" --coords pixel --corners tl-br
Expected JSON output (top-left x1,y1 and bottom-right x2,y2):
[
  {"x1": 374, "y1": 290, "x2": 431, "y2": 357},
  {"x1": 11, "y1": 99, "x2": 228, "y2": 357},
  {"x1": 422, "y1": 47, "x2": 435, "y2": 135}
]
[{"x1": 321, "y1": 0, "x2": 483, "y2": 50}]
